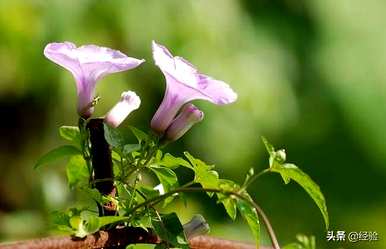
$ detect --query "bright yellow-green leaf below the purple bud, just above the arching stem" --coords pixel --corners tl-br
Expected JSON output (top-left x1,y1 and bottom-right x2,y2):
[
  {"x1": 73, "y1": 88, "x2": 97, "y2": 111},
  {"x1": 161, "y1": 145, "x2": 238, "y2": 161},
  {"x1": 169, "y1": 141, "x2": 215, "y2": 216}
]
[{"x1": 184, "y1": 152, "x2": 219, "y2": 196}]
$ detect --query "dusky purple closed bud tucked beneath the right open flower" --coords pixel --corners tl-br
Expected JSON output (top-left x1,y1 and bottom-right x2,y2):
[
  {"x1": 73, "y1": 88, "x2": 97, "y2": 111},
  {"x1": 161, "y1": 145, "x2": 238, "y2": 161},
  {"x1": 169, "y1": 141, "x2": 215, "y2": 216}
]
[{"x1": 165, "y1": 103, "x2": 204, "y2": 141}]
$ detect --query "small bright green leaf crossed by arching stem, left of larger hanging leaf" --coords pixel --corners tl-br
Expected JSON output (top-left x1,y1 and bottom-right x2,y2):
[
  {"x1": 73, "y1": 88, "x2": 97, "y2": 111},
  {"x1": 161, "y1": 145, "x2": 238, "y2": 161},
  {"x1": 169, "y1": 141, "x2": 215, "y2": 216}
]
[{"x1": 217, "y1": 179, "x2": 240, "y2": 220}]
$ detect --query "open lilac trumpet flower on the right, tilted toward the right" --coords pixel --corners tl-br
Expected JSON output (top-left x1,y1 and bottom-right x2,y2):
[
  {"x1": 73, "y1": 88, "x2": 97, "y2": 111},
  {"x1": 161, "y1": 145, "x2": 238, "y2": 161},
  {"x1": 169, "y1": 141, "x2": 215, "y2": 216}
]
[{"x1": 151, "y1": 41, "x2": 237, "y2": 134}]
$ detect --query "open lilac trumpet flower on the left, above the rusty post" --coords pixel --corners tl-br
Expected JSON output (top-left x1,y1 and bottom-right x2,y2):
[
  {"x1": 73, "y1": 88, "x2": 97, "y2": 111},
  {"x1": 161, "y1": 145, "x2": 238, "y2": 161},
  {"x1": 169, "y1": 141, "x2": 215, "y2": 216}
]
[{"x1": 44, "y1": 42, "x2": 144, "y2": 118}]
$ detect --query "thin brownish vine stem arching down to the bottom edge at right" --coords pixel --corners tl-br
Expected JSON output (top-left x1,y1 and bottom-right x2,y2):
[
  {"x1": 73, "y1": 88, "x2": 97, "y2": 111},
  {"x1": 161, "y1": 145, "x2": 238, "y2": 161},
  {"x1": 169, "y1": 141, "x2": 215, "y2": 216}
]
[{"x1": 128, "y1": 187, "x2": 280, "y2": 249}]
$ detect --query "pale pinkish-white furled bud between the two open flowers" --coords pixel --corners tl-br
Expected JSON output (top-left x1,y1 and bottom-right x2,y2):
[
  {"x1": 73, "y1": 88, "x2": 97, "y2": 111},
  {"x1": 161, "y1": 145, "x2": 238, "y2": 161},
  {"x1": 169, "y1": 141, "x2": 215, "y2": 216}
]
[{"x1": 105, "y1": 91, "x2": 141, "y2": 128}]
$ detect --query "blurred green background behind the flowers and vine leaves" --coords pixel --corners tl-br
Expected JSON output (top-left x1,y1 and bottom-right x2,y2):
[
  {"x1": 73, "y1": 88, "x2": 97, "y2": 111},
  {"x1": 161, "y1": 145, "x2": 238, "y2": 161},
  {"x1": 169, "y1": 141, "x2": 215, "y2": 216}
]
[{"x1": 0, "y1": 0, "x2": 386, "y2": 249}]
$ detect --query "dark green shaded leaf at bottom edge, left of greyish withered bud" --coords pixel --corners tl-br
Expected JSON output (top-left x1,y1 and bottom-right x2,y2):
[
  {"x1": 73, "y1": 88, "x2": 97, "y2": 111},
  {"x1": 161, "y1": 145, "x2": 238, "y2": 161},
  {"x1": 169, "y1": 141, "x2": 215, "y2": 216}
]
[{"x1": 152, "y1": 213, "x2": 189, "y2": 249}]
